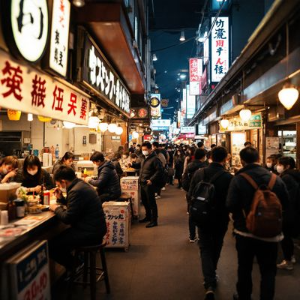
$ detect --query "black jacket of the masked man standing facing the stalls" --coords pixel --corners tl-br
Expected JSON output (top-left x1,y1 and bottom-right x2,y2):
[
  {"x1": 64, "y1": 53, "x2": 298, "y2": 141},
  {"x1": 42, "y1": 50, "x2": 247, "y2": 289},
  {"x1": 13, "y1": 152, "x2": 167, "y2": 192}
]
[{"x1": 132, "y1": 151, "x2": 163, "y2": 186}]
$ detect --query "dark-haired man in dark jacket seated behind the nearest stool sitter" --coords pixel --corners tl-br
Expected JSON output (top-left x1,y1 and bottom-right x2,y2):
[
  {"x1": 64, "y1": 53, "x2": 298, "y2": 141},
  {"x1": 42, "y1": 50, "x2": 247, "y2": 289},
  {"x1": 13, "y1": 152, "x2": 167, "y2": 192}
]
[{"x1": 89, "y1": 151, "x2": 121, "y2": 203}]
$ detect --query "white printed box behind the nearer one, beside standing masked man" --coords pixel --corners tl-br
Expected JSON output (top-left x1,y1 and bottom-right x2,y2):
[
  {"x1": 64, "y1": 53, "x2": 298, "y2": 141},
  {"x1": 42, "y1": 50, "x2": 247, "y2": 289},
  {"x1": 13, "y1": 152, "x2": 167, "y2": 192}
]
[{"x1": 121, "y1": 176, "x2": 140, "y2": 217}]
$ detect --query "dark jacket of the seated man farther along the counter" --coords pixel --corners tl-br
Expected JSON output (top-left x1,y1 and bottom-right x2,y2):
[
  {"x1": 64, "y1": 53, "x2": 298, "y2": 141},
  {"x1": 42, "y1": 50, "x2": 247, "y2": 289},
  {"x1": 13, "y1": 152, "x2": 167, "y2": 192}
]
[{"x1": 89, "y1": 161, "x2": 121, "y2": 200}]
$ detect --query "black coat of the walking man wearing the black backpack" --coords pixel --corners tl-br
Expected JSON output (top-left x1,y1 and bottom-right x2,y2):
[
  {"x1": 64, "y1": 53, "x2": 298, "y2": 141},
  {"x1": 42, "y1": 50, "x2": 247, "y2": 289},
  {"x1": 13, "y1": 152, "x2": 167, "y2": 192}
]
[{"x1": 188, "y1": 162, "x2": 233, "y2": 228}]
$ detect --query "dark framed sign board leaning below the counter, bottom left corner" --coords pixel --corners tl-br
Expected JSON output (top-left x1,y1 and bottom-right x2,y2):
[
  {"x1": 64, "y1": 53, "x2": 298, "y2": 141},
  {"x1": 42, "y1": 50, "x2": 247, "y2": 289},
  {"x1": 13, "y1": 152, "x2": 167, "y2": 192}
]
[{"x1": 6, "y1": 241, "x2": 51, "y2": 300}]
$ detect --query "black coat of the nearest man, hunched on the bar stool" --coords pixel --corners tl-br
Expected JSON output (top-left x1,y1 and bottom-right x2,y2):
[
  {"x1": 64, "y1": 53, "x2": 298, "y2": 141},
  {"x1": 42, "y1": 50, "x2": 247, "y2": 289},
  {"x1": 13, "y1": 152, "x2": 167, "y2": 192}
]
[{"x1": 55, "y1": 178, "x2": 106, "y2": 239}]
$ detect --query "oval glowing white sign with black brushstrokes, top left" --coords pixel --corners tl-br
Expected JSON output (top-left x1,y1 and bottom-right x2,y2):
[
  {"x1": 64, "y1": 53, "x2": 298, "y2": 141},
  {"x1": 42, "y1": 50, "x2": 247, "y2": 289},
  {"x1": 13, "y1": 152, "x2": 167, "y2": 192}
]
[{"x1": 9, "y1": 0, "x2": 49, "y2": 62}]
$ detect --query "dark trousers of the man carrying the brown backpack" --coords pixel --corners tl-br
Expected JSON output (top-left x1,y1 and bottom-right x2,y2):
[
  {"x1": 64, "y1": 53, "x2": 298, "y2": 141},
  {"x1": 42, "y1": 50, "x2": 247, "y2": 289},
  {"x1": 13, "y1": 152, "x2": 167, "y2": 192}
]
[{"x1": 236, "y1": 235, "x2": 278, "y2": 300}]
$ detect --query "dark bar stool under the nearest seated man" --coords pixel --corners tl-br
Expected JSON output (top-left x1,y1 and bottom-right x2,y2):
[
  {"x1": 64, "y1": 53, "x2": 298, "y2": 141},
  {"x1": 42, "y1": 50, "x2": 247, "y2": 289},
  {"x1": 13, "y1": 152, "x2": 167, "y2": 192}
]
[{"x1": 72, "y1": 241, "x2": 110, "y2": 300}]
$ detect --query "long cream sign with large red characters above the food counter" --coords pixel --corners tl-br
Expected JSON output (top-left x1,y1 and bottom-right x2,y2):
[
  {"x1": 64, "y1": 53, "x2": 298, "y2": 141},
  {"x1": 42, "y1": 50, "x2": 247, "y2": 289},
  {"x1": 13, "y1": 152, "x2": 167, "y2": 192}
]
[{"x1": 0, "y1": 51, "x2": 89, "y2": 125}]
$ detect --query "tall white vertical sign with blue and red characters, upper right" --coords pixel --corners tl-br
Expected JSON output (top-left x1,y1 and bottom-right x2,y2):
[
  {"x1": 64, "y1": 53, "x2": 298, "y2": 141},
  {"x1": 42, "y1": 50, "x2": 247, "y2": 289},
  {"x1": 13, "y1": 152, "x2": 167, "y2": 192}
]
[{"x1": 211, "y1": 17, "x2": 229, "y2": 82}]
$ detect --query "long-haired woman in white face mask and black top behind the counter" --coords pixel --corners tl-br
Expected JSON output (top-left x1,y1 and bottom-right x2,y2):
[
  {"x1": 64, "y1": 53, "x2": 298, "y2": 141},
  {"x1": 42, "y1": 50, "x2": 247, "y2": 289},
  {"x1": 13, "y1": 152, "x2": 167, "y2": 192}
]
[{"x1": 15, "y1": 155, "x2": 54, "y2": 194}]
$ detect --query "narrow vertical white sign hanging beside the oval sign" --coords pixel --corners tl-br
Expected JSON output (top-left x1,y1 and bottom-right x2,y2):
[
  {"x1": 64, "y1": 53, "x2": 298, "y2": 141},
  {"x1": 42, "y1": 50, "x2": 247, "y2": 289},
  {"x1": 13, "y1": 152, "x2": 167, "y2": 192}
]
[{"x1": 49, "y1": 0, "x2": 71, "y2": 77}]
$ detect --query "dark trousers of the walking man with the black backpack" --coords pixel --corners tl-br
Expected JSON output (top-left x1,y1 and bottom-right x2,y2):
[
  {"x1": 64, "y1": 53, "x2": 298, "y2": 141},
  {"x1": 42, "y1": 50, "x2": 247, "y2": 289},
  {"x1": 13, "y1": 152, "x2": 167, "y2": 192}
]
[{"x1": 198, "y1": 225, "x2": 227, "y2": 289}]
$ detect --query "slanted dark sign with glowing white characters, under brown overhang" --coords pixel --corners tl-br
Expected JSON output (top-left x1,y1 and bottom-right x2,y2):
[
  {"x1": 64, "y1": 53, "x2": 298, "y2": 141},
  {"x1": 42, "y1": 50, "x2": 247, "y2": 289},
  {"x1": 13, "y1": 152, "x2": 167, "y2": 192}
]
[{"x1": 82, "y1": 34, "x2": 130, "y2": 116}]
